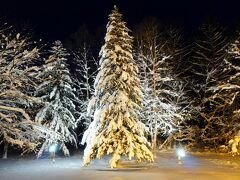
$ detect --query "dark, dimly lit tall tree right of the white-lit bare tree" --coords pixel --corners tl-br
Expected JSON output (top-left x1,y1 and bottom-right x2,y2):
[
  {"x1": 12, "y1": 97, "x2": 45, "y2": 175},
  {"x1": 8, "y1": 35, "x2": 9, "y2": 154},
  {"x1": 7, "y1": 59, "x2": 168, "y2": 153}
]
[{"x1": 189, "y1": 24, "x2": 228, "y2": 148}]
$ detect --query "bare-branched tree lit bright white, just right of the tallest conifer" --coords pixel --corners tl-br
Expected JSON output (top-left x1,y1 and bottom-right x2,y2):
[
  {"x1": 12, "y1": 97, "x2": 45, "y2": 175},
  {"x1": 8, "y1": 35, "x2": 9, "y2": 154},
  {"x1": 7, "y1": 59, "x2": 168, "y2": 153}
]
[{"x1": 135, "y1": 18, "x2": 188, "y2": 152}]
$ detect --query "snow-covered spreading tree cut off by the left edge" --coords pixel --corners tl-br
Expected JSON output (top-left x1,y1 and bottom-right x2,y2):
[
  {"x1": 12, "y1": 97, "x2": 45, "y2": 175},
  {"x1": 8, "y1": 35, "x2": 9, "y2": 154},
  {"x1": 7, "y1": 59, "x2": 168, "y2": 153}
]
[{"x1": 0, "y1": 28, "x2": 40, "y2": 158}]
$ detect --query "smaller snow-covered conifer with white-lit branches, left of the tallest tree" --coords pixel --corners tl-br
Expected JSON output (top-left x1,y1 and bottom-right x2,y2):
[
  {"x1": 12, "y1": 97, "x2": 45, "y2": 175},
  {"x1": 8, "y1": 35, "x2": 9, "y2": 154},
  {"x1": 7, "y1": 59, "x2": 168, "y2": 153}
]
[{"x1": 35, "y1": 41, "x2": 78, "y2": 156}]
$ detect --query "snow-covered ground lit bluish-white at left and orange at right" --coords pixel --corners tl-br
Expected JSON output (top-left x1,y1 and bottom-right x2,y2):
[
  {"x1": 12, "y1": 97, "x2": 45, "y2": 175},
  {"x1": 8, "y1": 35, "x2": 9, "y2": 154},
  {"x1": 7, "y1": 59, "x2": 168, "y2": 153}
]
[{"x1": 0, "y1": 153, "x2": 240, "y2": 180}]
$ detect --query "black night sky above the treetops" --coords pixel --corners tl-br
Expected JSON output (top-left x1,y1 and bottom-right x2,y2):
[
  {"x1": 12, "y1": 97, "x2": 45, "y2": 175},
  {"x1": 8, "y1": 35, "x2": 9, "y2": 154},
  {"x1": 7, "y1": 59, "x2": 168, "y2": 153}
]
[{"x1": 0, "y1": 0, "x2": 240, "y2": 39}]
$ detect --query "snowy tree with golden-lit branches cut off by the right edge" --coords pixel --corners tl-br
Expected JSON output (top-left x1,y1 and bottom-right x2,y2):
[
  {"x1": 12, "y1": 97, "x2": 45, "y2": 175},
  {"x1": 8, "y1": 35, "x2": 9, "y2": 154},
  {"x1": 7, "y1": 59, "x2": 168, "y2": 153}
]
[{"x1": 213, "y1": 40, "x2": 240, "y2": 152}]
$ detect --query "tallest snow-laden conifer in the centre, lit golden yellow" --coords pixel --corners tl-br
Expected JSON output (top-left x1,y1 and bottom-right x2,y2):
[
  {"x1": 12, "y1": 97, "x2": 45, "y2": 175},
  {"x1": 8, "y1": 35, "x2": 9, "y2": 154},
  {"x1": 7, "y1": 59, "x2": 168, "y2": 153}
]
[{"x1": 82, "y1": 7, "x2": 153, "y2": 168}]
